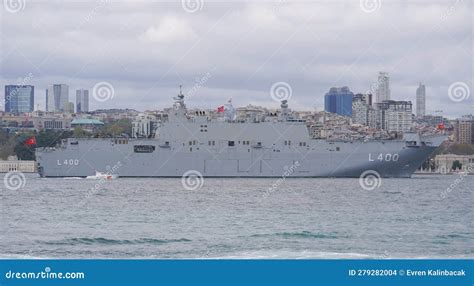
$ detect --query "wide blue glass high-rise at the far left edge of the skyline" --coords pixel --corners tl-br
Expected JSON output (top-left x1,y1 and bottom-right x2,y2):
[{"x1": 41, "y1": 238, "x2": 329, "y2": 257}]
[{"x1": 5, "y1": 85, "x2": 35, "y2": 114}]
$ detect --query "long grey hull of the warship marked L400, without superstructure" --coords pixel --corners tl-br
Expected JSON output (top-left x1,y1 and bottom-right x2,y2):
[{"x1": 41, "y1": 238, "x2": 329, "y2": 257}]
[{"x1": 36, "y1": 139, "x2": 436, "y2": 178}]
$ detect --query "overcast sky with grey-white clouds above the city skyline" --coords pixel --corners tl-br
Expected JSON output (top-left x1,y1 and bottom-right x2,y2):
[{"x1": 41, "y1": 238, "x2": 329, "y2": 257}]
[{"x1": 0, "y1": 0, "x2": 474, "y2": 117}]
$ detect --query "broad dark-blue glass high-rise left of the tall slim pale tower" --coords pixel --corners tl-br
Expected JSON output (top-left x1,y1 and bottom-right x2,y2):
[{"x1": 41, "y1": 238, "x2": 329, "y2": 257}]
[{"x1": 324, "y1": 86, "x2": 354, "y2": 116}]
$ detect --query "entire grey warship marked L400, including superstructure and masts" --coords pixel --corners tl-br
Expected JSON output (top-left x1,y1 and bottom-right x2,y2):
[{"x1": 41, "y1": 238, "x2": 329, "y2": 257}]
[{"x1": 36, "y1": 93, "x2": 445, "y2": 178}]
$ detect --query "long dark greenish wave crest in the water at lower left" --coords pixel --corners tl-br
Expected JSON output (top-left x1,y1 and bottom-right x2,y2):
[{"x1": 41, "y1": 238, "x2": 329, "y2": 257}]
[{"x1": 44, "y1": 237, "x2": 191, "y2": 245}]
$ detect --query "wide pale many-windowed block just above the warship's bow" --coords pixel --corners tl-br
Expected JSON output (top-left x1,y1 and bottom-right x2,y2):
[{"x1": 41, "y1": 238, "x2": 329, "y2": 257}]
[{"x1": 376, "y1": 100, "x2": 413, "y2": 132}]
